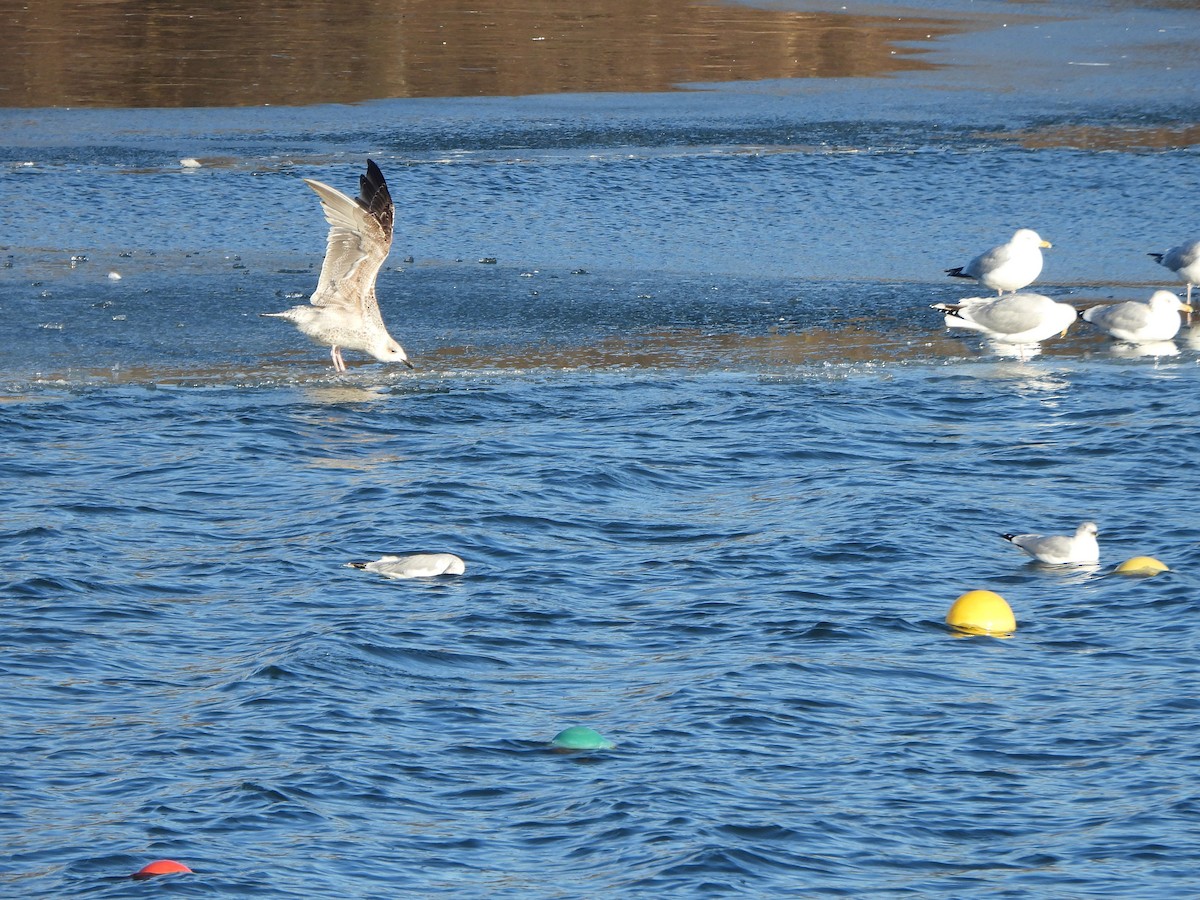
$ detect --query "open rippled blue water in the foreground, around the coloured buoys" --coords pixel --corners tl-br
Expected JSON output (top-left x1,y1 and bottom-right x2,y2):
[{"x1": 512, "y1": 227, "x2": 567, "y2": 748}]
[{"x1": 7, "y1": 359, "x2": 1200, "y2": 896}]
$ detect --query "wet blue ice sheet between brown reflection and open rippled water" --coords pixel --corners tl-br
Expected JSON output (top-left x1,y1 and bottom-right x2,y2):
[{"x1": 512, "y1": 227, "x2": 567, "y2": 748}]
[{"x1": 0, "y1": 90, "x2": 1196, "y2": 379}]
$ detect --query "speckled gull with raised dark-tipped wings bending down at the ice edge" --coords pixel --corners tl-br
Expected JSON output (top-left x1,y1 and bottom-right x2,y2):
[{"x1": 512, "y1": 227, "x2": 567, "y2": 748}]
[{"x1": 263, "y1": 160, "x2": 413, "y2": 372}]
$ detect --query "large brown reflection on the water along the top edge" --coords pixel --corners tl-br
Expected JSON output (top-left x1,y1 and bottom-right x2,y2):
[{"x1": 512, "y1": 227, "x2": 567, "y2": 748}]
[{"x1": 0, "y1": 0, "x2": 964, "y2": 107}]
